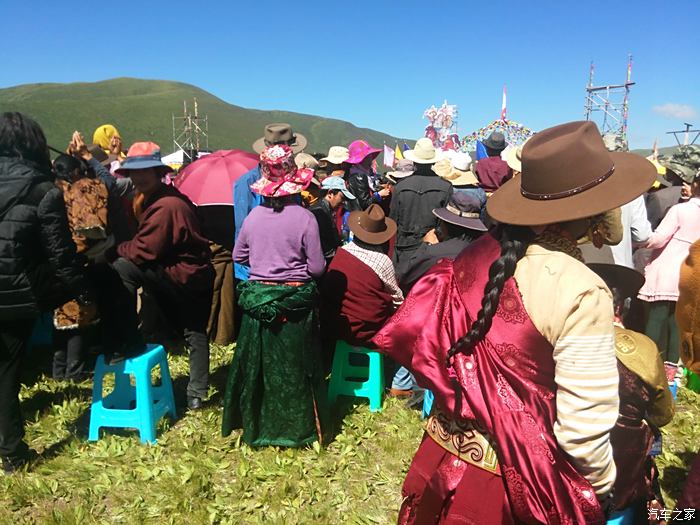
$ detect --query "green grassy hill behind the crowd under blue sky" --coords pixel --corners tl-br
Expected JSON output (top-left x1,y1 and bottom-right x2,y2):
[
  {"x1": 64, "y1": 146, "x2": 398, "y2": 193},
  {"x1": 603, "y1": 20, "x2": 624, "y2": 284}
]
[{"x1": 0, "y1": 78, "x2": 410, "y2": 153}]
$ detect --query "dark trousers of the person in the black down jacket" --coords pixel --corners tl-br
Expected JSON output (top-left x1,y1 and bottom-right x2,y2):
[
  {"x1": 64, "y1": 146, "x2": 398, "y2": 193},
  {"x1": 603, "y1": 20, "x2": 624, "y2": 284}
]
[{"x1": 0, "y1": 319, "x2": 34, "y2": 459}]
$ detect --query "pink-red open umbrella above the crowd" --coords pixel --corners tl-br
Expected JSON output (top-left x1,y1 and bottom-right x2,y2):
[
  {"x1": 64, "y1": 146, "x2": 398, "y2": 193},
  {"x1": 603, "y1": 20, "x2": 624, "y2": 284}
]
[{"x1": 174, "y1": 149, "x2": 260, "y2": 206}]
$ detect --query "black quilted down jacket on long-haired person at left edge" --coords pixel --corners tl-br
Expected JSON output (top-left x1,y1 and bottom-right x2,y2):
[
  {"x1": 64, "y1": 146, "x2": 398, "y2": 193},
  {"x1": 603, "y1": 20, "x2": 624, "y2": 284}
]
[{"x1": 0, "y1": 157, "x2": 86, "y2": 321}]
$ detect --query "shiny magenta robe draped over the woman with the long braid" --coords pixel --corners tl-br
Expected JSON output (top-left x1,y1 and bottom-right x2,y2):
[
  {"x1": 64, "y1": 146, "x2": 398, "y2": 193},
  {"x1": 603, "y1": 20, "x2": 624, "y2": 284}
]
[{"x1": 373, "y1": 235, "x2": 605, "y2": 525}]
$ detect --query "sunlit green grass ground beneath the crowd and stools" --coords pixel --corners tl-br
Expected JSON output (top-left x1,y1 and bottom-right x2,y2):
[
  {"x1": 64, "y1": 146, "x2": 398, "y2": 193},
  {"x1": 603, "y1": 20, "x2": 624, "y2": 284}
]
[{"x1": 0, "y1": 347, "x2": 700, "y2": 525}]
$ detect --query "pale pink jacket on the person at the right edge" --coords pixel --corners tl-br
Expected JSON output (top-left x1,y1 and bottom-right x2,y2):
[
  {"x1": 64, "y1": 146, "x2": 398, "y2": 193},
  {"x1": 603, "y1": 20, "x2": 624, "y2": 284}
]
[{"x1": 639, "y1": 197, "x2": 700, "y2": 301}]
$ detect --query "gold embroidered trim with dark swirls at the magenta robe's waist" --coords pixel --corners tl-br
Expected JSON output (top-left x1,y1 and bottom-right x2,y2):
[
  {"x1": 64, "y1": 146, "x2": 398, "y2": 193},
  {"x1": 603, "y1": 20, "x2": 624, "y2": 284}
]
[{"x1": 425, "y1": 405, "x2": 501, "y2": 476}]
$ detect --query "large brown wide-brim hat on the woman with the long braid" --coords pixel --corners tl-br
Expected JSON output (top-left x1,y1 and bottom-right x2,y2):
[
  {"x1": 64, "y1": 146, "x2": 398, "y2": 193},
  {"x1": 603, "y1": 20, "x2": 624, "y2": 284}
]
[{"x1": 486, "y1": 121, "x2": 656, "y2": 226}]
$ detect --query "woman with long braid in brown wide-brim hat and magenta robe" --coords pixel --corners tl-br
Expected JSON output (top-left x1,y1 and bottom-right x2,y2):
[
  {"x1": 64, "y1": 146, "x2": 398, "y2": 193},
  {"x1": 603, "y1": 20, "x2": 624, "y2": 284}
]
[{"x1": 373, "y1": 122, "x2": 655, "y2": 524}]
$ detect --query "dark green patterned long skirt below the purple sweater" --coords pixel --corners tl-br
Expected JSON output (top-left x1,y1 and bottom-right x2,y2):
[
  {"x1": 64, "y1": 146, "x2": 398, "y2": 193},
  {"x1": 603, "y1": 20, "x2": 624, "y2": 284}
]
[{"x1": 222, "y1": 281, "x2": 323, "y2": 447}]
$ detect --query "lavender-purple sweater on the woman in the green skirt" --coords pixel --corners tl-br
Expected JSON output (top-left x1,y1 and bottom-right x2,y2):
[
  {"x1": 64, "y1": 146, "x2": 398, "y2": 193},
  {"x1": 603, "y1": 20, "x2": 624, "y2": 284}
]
[{"x1": 233, "y1": 204, "x2": 326, "y2": 282}]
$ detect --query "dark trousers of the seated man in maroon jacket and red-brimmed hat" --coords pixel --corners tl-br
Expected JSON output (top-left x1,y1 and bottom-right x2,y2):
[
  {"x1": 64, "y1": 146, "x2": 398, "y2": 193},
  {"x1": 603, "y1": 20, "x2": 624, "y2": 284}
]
[{"x1": 112, "y1": 258, "x2": 211, "y2": 398}]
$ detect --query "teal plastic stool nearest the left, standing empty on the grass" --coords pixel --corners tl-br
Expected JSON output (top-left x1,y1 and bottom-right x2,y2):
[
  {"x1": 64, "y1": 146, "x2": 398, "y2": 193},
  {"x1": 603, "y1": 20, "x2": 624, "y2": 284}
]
[{"x1": 88, "y1": 345, "x2": 176, "y2": 443}]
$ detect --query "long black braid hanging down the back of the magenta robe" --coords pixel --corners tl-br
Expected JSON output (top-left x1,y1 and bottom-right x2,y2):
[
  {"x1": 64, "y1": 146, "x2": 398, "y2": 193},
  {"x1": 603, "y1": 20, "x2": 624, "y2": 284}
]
[{"x1": 447, "y1": 224, "x2": 535, "y2": 366}]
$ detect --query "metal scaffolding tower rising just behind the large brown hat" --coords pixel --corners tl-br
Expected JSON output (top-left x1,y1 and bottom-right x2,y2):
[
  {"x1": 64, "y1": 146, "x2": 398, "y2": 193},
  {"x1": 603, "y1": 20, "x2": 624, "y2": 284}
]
[{"x1": 585, "y1": 55, "x2": 635, "y2": 143}]
